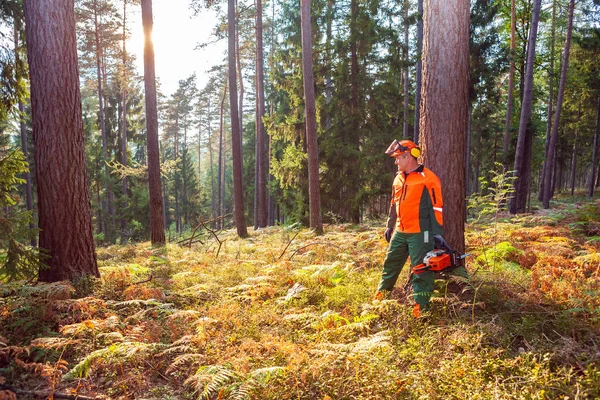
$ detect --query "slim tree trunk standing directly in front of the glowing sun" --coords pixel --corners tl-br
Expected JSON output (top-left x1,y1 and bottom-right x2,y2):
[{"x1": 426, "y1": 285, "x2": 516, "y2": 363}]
[{"x1": 142, "y1": 0, "x2": 165, "y2": 244}]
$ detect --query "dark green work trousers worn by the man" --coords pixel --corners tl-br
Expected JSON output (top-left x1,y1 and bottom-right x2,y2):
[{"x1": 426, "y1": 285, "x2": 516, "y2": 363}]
[{"x1": 377, "y1": 231, "x2": 469, "y2": 310}]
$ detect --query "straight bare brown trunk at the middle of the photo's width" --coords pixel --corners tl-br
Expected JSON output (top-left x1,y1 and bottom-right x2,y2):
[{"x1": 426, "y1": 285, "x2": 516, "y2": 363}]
[{"x1": 300, "y1": 0, "x2": 323, "y2": 235}]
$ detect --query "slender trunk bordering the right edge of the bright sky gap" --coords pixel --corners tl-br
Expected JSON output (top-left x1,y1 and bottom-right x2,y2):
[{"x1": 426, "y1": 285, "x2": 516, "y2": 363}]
[{"x1": 227, "y1": 0, "x2": 248, "y2": 237}]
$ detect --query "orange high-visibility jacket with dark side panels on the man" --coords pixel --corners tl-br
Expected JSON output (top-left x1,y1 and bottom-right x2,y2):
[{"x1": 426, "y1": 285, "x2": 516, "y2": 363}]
[{"x1": 388, "y1": 165, "x2": 444, "y2": 237}]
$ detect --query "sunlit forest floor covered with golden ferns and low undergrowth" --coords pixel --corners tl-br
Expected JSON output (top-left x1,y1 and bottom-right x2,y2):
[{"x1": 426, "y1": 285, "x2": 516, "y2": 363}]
[{"x1": 0, "y1": 198, "x2": 600, "y2": 400}]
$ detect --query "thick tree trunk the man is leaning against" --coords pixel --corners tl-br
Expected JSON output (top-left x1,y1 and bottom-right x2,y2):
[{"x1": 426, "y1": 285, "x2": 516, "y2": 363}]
[{"x1": 420, "y1": 0, "x2": 469, "y2": 252}]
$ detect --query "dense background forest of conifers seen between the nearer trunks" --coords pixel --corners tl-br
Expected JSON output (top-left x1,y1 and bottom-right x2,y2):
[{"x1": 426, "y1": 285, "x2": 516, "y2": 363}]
[{"x1": 2, "y1": 0, "x2": 600, "y2": 250}]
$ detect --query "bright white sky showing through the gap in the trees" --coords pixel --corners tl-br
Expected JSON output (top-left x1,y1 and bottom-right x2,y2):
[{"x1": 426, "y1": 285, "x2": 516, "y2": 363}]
[{"x1": 127, "y1": 0, "x2": 227, "y2": 96}]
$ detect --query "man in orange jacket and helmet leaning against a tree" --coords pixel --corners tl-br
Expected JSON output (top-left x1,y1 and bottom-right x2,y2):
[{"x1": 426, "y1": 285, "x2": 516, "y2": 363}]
[{"x1": 375, "y1": 140, "x2": 466, "y2": 318}]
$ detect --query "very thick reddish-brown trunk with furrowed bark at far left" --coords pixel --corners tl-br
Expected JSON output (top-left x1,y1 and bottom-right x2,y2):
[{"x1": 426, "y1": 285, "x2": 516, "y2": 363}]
[{"x1": 24, "y1": 0, "x2": 100, "y2": 282}]
